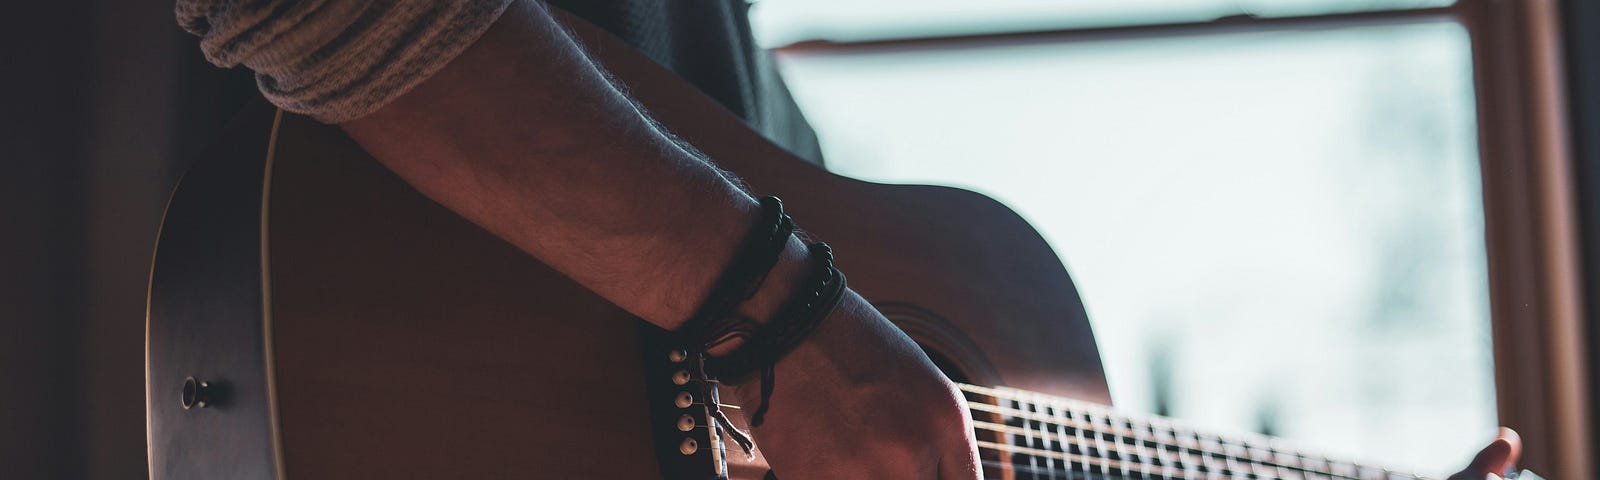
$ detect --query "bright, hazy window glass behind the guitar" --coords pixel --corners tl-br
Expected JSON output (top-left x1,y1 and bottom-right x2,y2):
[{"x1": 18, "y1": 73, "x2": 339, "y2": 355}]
[{"x1": 754, "y1": 0, "x2": 1496, "y2": 474}]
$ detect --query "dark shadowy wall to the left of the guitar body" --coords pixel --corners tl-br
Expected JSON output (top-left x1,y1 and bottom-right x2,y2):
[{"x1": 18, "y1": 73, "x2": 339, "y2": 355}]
[{"x1": 0, "y1": 0, "x2": 253, "y2": 478}]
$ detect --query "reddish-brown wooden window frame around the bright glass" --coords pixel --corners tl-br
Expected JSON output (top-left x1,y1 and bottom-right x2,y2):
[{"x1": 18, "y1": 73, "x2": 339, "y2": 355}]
[{"x1": 774, "y1": 0, "x2": 1597, "y2": 478}]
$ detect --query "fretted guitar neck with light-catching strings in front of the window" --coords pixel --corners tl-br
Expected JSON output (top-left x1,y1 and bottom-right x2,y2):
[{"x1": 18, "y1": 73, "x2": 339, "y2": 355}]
[{"x1": 960, "y1": 384, "x2": 1424, "y2": 480}]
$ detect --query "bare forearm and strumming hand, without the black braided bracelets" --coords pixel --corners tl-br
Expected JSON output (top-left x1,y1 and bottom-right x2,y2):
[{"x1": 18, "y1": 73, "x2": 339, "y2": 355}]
[{"x1": 193, "y1": 0, "x2": 978, "y2": 480}]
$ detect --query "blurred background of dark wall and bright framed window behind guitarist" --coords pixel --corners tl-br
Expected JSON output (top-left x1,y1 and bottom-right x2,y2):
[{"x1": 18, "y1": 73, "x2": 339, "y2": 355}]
[{"x1": 0, "y1": 0, "x2": 1600, "y2": 478}]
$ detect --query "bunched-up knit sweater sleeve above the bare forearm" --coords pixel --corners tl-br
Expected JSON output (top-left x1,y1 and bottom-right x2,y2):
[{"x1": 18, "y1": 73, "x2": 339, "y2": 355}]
[{"x1": 176, "y1": 0, "x2": 514, "y2": 123}]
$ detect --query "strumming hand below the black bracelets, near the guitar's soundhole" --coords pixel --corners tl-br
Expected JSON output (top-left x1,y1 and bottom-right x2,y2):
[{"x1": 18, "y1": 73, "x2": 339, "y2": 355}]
[{"x1": 733, "y1": 293, "x2": 979, "y2": 480}]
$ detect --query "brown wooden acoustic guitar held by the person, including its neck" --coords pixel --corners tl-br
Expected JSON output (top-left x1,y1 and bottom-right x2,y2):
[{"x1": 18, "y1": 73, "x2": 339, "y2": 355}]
[{"x1": 146, "y1": 8, "x2": 1523, "y2": 478}]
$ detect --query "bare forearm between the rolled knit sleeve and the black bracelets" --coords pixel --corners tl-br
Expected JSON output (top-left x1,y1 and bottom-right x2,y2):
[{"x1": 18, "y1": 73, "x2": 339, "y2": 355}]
[{"x1": 342, "y1": 2, "x2": 792, "y2": 328}]
